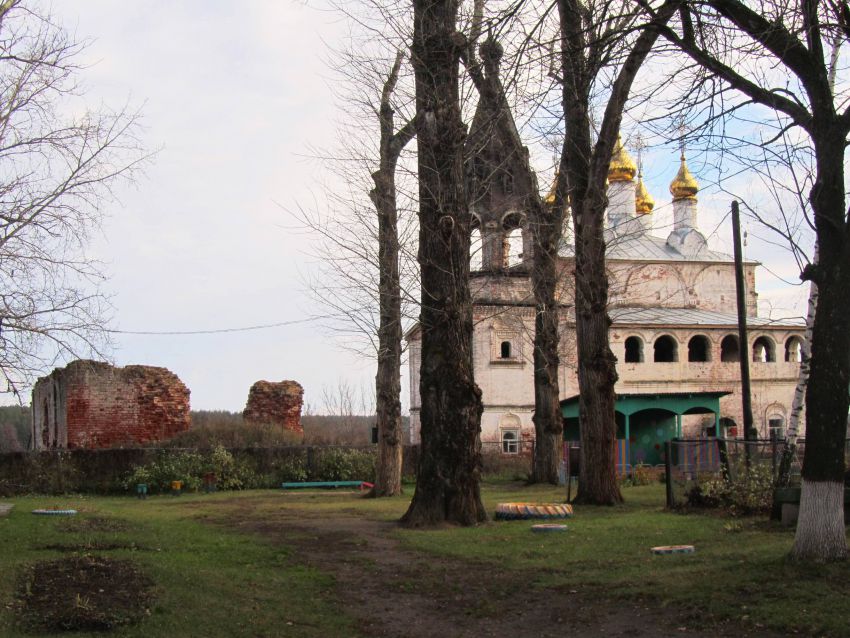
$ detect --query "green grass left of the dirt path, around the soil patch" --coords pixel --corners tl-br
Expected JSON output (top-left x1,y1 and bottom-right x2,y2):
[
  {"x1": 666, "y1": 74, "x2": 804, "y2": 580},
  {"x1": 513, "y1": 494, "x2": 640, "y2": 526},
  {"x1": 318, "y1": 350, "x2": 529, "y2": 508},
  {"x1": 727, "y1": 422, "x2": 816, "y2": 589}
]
[{"x1": 0, "y1": 493, "x2": 355, "y2": 637}]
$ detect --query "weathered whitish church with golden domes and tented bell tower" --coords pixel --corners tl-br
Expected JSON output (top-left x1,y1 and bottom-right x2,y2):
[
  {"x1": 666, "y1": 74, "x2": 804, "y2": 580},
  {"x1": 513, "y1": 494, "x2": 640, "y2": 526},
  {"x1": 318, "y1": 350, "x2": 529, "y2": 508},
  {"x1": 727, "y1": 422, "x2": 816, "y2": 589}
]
[{"x1": 407, "y1": 135, "x2": 804, "y2": 453}]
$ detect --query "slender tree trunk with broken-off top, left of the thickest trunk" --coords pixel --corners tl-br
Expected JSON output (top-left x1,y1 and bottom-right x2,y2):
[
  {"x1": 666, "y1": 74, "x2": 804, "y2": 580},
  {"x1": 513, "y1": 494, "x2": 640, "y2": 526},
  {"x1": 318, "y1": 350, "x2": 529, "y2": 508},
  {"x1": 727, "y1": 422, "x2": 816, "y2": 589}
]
[{"x1": 370, "y1": 53, "x2": 415, "y2": 496}]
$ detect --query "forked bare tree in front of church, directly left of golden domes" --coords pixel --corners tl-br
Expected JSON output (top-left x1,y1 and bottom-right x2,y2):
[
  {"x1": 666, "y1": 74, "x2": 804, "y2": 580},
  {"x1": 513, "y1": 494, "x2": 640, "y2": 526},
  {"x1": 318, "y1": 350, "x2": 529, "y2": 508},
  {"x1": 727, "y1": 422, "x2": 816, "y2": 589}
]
[{"x1": 556, "y1": 0, "x2": 679, "y2": 504}]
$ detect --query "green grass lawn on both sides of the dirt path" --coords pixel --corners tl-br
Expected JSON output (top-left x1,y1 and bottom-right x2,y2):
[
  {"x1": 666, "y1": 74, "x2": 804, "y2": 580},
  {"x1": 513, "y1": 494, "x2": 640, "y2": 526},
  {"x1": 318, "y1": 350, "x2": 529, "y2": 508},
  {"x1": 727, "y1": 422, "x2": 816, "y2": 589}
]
[{"x1": 0, "y1": 483, "x2": 850, "y2": 638}]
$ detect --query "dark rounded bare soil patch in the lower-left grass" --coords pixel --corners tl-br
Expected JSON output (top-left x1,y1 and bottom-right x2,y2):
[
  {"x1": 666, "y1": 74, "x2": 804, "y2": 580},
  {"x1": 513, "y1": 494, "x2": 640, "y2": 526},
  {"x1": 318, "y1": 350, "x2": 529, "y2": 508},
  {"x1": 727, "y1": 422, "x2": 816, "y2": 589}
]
[{"x1": 16, "y1": 555, "x2": 153, "y2": 634}]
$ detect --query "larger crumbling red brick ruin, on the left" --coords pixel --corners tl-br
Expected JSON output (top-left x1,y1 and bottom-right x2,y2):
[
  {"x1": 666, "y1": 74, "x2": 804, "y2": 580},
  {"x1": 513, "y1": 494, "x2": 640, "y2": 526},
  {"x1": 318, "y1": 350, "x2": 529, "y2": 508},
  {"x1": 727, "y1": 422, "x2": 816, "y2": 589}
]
[{"x1": 31, "y1": 361, "x2": 190, "y2": 450}]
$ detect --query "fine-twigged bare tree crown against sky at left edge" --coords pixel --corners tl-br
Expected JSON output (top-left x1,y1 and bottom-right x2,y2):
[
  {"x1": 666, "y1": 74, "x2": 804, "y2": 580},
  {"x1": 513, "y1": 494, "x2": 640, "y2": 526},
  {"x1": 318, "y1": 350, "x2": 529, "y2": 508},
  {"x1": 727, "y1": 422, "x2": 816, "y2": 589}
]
[{"x1": 0, "y1": 0, "x2": 146, "y2": 394}]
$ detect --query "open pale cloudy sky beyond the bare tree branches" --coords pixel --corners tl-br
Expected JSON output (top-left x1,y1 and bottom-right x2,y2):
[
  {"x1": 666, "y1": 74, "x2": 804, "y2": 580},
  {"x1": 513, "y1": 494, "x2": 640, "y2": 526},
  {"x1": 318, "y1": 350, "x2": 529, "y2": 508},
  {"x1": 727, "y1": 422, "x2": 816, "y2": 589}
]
[{"x1": 11, "y1": 0, "x2": 804, "y2": 412}]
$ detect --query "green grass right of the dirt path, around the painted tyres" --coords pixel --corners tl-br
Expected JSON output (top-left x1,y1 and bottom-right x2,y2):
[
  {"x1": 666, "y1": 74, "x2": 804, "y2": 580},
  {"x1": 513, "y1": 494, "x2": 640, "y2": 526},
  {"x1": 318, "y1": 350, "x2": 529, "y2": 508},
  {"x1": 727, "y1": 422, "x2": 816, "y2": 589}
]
[{"x1": 402, "y1": 485, "x2": 850, "y2": 636}]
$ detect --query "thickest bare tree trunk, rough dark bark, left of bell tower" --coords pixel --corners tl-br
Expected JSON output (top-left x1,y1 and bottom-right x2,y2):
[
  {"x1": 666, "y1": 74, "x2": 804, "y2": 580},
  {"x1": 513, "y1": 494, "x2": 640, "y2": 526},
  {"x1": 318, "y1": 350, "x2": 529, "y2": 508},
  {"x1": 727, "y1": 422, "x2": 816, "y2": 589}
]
[{"x1": 401, "y1": 0, "x2": 487, "y2": 527}]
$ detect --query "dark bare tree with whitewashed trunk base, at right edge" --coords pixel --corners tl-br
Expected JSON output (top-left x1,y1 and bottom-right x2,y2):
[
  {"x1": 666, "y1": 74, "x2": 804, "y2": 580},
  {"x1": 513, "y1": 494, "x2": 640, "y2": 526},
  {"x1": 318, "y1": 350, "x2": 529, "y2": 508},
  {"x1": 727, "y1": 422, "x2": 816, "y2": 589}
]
[{"x1": 644, "y1": 0, "x2": 850, "y2": 561}]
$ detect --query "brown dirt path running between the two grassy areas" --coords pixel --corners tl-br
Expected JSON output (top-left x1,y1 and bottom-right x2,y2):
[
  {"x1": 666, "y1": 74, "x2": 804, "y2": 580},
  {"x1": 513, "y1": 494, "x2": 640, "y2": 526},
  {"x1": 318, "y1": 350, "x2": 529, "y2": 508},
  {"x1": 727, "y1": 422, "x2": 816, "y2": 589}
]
[{"x1": 207, "y1": 502, "x2": 777, "y2": 638}]
